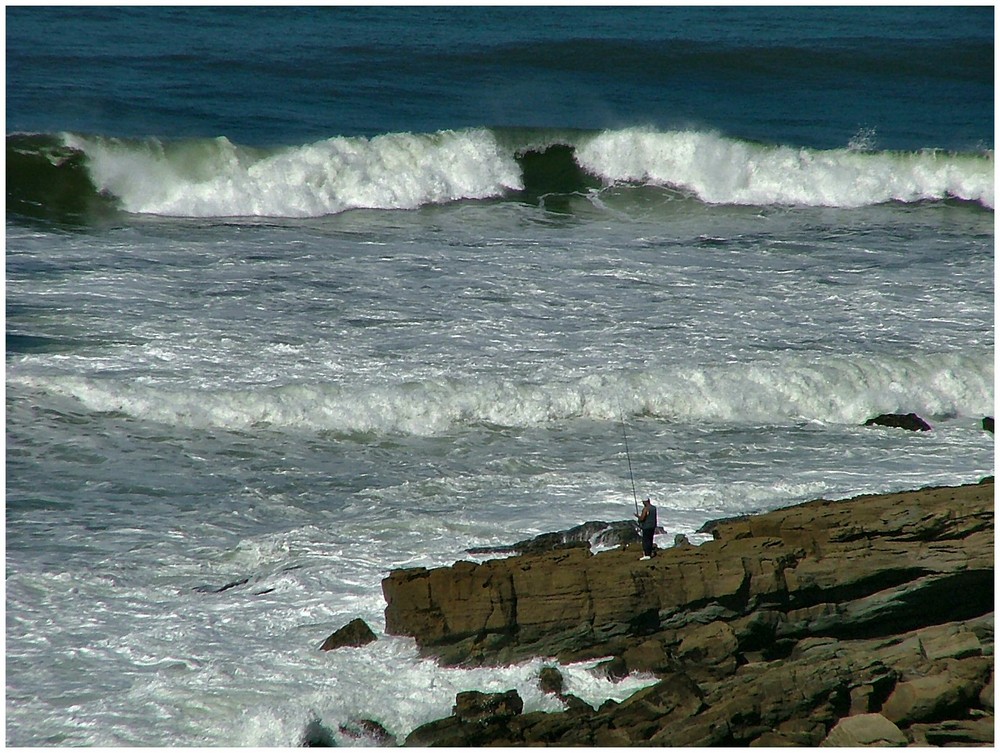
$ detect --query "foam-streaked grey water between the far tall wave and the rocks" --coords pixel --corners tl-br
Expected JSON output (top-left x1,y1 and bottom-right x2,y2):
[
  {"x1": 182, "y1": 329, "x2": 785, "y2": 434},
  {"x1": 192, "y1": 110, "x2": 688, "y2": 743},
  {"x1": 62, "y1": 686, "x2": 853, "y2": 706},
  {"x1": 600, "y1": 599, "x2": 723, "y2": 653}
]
[{"x1": 7, "y1": 178, "x2": 995, "y2": 746}]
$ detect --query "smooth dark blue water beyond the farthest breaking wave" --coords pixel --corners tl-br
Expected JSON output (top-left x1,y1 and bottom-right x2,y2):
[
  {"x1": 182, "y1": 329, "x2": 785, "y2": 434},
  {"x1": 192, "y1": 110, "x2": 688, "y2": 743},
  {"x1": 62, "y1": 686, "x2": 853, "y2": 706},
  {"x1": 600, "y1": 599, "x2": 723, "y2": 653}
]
[{"x1": 7, "y1": 7, "x2": 994, "y2": 151}]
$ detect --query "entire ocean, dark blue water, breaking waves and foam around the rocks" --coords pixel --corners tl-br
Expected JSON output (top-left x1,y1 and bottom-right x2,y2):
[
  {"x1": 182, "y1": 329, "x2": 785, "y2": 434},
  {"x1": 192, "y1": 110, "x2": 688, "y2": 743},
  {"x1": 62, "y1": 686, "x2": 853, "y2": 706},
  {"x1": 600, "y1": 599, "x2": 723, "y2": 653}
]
[{"x1": 5, "y1": 6, "x2": 995, "y2": 747}]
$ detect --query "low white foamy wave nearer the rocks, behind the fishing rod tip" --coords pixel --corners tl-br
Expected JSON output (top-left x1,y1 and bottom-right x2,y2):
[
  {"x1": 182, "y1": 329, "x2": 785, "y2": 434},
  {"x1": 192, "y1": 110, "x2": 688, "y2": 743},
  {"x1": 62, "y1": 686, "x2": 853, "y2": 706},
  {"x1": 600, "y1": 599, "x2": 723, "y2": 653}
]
[{"x1": 12, "y1": 353, "x2": 994, "y2": 435}]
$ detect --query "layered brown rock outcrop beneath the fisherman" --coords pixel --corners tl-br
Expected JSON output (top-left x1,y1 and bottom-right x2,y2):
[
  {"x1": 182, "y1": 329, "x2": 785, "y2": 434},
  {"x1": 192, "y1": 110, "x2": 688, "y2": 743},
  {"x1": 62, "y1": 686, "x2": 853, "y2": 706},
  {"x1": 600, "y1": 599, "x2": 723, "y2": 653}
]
[{"x1": 383, "y1": 482, "x2": 993, "y2": 746}]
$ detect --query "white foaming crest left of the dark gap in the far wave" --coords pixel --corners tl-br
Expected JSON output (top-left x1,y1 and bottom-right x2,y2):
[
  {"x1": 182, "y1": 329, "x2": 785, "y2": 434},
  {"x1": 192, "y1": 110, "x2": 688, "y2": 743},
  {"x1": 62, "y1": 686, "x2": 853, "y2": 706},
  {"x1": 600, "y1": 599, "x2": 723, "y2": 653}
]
[{"x1": 59, "y1": 130, "x2": 520, "y2": 217}]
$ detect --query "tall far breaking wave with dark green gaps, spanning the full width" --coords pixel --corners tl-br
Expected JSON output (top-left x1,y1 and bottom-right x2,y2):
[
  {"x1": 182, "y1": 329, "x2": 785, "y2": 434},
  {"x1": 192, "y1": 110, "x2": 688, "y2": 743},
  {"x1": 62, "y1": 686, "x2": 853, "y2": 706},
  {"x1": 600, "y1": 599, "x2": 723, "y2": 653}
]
[{"x1": 7, "y1": 128, "x2": 994, "y2": 220}]
